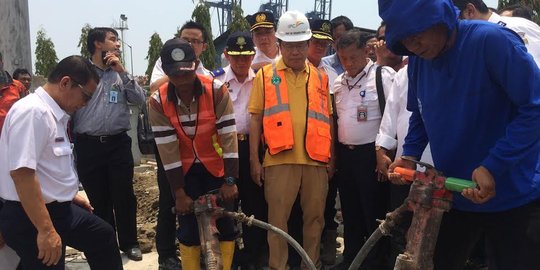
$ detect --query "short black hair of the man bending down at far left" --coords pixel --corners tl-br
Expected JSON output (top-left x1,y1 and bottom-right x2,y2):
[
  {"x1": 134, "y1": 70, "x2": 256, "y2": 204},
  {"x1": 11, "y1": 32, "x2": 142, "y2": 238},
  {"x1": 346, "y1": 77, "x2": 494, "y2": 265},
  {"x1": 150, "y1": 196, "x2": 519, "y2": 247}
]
[{"x1": 47, "y1": 55, "x2": 99, "y2": 85}]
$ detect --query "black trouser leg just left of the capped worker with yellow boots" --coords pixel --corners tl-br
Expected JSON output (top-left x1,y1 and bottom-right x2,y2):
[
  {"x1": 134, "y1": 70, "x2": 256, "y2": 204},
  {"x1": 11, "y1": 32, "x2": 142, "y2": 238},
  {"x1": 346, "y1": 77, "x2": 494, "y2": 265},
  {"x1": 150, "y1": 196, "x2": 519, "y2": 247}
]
[{"x1": 154, "y1": 144, "x2": 177, "y2": 261}]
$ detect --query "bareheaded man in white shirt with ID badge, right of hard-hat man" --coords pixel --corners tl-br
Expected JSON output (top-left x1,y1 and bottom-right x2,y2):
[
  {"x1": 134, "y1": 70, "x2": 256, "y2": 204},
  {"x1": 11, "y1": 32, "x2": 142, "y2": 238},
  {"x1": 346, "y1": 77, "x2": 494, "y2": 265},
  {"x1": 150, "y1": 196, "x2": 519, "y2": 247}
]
[{"x1": 334, "y1": 29, "x2": 395, "y2": 269}]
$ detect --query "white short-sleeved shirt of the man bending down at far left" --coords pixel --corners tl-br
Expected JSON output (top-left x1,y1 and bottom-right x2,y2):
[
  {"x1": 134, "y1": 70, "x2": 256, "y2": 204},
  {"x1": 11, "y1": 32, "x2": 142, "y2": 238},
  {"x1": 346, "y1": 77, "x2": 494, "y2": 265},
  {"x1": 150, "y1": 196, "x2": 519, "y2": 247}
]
[{"x1": 0, "y1": 87, "x2": 78, "y2": 203}]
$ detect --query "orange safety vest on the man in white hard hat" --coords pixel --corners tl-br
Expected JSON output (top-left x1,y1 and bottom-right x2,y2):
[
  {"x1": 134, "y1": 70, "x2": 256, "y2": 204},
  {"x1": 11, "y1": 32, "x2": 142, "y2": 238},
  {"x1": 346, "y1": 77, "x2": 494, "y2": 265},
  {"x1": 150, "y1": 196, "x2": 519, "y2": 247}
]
[{"x1": 263, "y1": 64, "x2": 332, "y2": 163}]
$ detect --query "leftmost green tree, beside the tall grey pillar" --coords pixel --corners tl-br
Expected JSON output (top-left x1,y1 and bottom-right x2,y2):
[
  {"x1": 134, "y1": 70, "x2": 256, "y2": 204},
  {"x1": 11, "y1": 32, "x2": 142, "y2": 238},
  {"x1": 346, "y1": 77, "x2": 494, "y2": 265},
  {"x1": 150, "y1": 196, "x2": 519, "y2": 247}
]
[{"x1": 36, "y1": 28, "x2": 58, "y2": 77}]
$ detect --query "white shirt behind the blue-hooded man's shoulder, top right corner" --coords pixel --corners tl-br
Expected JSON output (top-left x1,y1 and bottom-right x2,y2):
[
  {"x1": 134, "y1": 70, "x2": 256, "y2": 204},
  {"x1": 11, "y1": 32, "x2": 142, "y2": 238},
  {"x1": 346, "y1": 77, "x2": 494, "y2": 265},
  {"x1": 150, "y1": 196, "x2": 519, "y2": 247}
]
[{"x1": 488, "y1": 12, "x2": 540, "y2": 67}]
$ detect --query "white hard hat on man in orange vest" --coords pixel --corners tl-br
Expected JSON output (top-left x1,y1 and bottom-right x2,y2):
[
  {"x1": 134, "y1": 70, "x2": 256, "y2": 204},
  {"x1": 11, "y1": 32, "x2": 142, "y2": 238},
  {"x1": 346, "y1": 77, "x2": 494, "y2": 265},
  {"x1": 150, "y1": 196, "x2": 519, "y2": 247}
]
[{"x1": 276, "y1": 10, "x2": 311, "y2": 42}]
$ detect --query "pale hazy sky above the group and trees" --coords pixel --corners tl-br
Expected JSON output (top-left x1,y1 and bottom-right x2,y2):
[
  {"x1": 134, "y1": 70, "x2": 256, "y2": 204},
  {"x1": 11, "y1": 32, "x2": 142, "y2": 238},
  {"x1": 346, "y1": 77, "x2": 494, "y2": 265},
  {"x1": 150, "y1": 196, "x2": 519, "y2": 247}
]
[{"x1": 28, "y1": 0, "x2": 498, "y2": 75}]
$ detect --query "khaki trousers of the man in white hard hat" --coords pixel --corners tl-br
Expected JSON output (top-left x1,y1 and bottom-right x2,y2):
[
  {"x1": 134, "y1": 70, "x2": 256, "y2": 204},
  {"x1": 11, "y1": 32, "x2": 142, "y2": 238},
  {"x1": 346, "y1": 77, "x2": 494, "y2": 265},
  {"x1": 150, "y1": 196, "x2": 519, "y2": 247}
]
[{"x1": 264, "y1": 164, "x2": 328, "y2": 270}]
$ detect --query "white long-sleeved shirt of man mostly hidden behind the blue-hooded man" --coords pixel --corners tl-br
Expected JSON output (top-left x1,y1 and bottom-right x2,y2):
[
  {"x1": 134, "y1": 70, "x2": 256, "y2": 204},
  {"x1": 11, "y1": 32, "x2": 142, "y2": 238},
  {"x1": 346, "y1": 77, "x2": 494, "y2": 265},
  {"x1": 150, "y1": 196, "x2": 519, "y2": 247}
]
[{"x1": 375, "y1": 66, "x2": 433, "y2": 165}]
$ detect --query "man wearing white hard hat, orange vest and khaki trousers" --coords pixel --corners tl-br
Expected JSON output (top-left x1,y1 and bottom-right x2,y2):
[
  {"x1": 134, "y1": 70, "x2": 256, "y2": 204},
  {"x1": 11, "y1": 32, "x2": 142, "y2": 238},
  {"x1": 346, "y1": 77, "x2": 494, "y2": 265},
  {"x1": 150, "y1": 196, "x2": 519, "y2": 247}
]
[{"x1": 248, "y1": 11, "x2": 333, "y2": 270}]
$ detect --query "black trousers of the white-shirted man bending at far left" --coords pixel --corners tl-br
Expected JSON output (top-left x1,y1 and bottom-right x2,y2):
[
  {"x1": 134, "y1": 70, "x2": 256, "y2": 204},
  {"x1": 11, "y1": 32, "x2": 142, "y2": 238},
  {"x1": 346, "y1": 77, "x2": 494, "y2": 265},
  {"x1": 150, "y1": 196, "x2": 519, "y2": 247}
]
[{"x1": 0, "y1": 201, "x2": 123, "y2": 270}]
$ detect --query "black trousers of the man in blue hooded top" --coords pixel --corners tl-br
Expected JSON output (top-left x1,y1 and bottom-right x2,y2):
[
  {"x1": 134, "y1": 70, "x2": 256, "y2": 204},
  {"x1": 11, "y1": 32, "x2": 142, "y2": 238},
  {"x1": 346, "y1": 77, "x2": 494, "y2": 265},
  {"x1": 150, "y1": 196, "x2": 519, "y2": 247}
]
[{"x1": 434, "y1": 199, "x2": 540, "y2": 270}]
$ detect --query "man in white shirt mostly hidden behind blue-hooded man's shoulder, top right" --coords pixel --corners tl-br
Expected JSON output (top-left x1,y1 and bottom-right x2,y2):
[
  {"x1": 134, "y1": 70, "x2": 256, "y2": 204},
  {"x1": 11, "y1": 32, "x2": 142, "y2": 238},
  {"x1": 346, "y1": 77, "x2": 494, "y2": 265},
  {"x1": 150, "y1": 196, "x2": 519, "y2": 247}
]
[{"x1": 453, "y1": 0, "x2": 540, "y2": 65}]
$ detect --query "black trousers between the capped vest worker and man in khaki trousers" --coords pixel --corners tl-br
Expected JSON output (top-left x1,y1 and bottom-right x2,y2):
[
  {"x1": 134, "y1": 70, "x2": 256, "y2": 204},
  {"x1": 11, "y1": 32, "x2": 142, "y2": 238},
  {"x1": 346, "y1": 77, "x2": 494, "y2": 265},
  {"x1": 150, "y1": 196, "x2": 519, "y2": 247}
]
[{"x1": 235, "y1": 140, "x2": 268, "y2": 264}]
